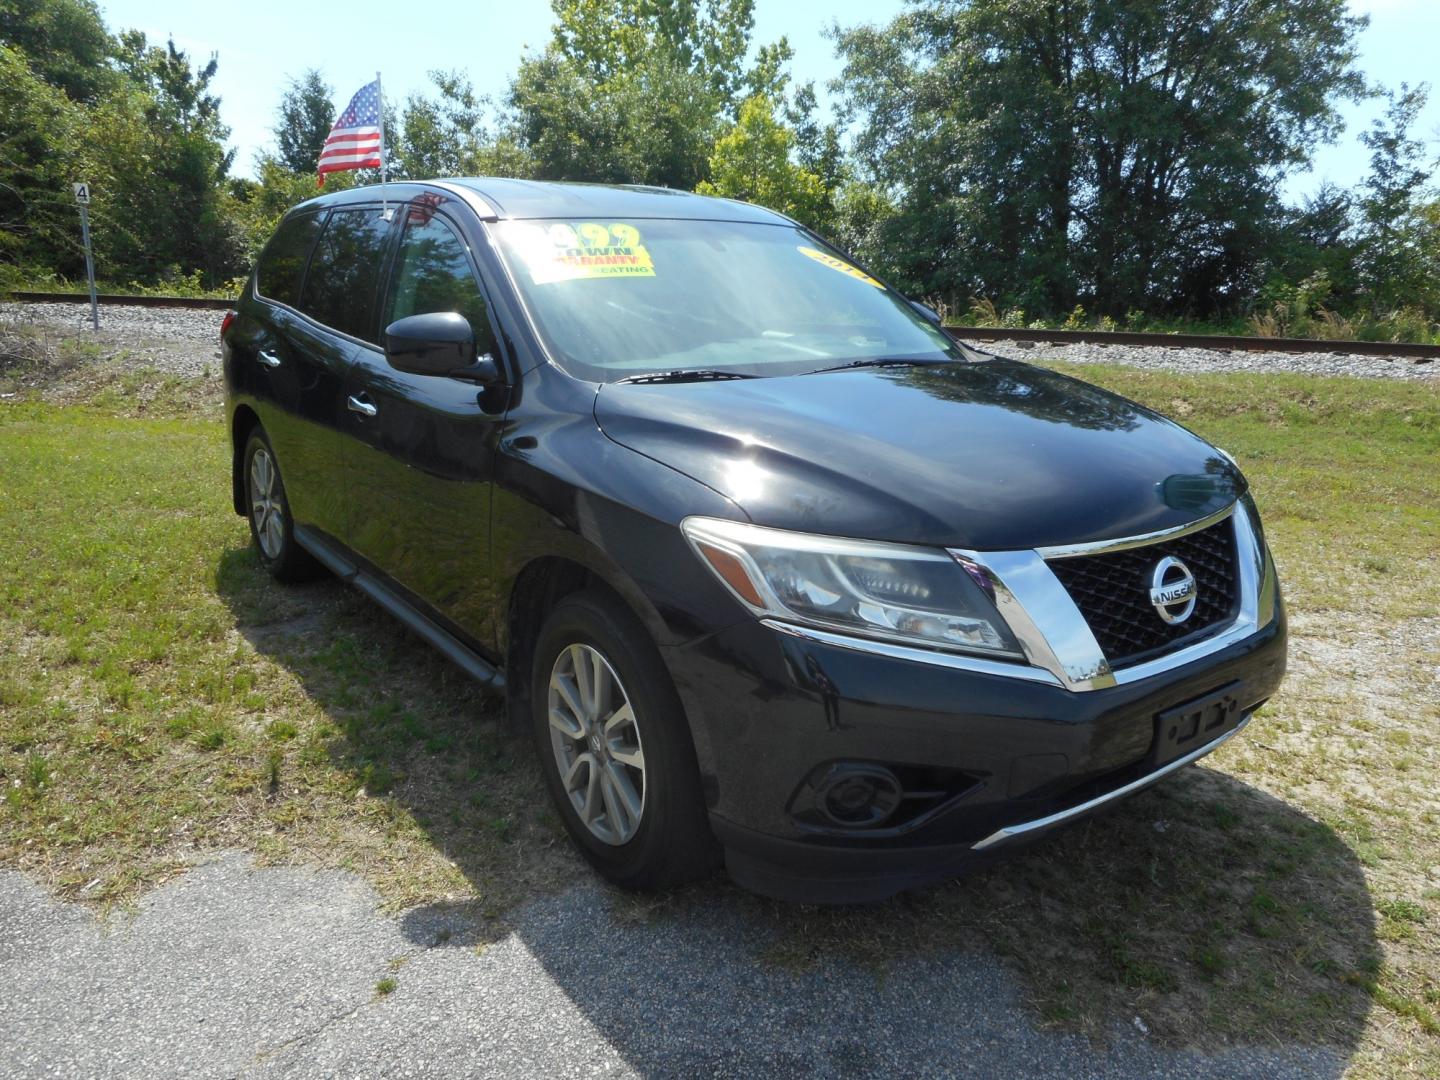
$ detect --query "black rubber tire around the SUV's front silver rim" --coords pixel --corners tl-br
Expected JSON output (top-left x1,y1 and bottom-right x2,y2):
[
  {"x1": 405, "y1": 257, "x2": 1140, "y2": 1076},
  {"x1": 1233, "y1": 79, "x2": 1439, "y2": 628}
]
[{"x1": 530, "y1": 590, "x2": 720, "y2": 891}]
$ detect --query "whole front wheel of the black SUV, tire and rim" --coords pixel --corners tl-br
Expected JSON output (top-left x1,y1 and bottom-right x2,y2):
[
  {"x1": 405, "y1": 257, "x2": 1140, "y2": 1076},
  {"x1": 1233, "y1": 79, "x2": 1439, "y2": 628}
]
[{"x1": 530, "y1": 592, "x2": 719, "y2": 890}]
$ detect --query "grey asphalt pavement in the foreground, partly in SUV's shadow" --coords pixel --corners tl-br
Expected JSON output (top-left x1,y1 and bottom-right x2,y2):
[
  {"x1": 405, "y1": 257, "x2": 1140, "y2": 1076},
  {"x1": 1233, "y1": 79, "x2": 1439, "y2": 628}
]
[{"x1": 0, "y1": 854, "x2": 1345, "y2": 1080}]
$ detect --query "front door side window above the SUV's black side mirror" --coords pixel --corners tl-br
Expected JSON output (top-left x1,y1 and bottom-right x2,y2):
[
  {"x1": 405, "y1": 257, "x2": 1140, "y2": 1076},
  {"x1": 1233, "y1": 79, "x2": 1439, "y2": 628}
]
[{"x1": 384, "y1": 209, "x2": 495, "y2": 356}]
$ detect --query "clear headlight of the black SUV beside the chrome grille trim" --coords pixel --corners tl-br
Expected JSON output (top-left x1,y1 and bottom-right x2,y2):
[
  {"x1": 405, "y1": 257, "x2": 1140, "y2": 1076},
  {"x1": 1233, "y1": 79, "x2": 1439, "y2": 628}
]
[{"x1": 680, "y1": 517, "x2": 1024, "y2": 660}]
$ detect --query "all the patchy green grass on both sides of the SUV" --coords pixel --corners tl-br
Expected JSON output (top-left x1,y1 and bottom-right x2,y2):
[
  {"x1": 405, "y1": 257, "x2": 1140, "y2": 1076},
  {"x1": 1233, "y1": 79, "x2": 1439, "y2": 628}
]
[{"x1": 0, "y1": 342, "x2": 1440, "y2": 1076}]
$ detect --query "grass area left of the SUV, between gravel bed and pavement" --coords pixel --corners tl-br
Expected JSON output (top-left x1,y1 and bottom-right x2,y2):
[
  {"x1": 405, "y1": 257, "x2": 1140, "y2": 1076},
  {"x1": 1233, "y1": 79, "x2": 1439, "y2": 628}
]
[{"x1": 0, "y1": 402, "x2": 573, "y2": 909}]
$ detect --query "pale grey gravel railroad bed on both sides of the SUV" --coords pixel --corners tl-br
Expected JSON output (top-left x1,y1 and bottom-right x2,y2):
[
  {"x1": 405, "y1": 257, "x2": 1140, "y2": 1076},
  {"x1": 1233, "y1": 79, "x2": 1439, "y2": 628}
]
[{"x1": 0, "y1": 304, "x2": 1440, "y2": 384}]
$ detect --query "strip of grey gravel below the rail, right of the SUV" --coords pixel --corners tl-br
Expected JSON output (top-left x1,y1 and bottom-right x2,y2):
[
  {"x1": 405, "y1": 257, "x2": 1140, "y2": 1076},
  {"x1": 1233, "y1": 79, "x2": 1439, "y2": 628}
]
[{"x1": 969, "y1": 338, "x2": 1440, "y2": 384}]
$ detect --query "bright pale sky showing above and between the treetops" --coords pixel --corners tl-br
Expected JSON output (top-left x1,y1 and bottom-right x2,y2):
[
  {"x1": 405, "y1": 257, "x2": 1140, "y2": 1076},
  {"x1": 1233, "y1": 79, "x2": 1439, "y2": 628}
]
[{"x1": 101, "y1": 0, "x2": 1440, "y2": 199}]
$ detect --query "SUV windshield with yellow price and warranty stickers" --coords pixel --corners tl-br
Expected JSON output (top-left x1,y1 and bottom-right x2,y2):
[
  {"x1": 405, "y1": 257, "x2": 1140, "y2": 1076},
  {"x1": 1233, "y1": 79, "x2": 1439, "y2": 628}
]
[{"x1": 497, "y1": 219, "x2": 960, "y2": 382}]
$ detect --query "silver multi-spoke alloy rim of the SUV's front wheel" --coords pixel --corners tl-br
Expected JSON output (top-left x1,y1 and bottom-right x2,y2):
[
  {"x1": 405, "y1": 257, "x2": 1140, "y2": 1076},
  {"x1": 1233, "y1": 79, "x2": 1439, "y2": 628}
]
[{"x1": 546, "y1": 644, "x2": 647, "y2": 845}]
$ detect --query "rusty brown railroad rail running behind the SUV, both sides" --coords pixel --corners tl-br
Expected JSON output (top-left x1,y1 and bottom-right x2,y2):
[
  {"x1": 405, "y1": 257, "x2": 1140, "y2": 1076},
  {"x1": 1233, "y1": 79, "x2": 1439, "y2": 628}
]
[{"x1": 10, "y1": 292, "x2": 1440, "y2": 363}]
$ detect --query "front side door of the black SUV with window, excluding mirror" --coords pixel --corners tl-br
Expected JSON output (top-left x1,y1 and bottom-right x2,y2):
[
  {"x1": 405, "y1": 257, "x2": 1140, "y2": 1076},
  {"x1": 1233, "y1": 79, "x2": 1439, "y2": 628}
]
[{"x1": 346, "y1": 197, "x2": 504, "y2": 642}]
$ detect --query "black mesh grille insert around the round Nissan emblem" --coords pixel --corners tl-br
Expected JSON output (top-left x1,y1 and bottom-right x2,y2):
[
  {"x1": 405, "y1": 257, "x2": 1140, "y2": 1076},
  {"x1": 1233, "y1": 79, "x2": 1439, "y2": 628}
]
[{"x1": 1050, "y1": 517, "x2": 1240, "y2": 668}]
